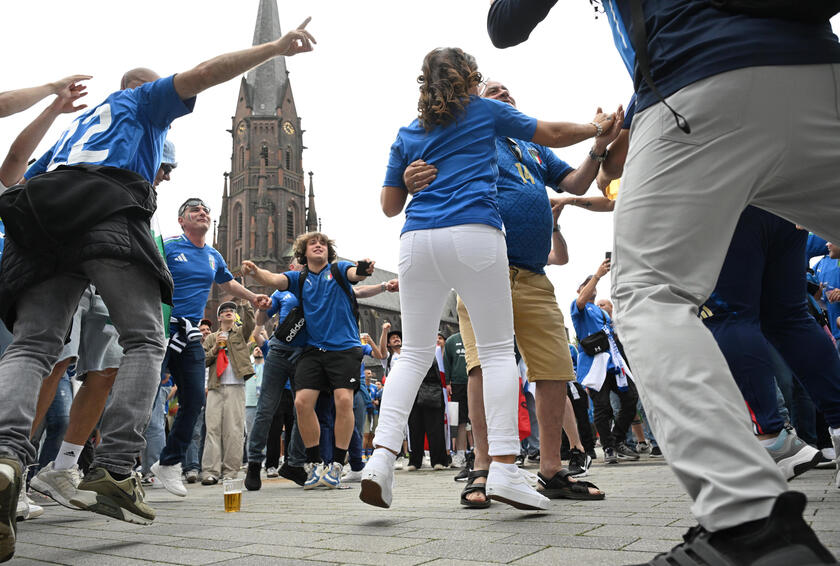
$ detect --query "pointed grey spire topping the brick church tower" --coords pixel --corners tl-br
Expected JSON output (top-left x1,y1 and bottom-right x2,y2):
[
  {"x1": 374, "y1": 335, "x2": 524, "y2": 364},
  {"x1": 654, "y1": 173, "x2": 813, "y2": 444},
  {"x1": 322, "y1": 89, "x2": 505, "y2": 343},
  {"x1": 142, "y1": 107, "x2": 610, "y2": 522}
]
[{"x1": 245, "y1": 0, "x2": 288, "y2": 116}]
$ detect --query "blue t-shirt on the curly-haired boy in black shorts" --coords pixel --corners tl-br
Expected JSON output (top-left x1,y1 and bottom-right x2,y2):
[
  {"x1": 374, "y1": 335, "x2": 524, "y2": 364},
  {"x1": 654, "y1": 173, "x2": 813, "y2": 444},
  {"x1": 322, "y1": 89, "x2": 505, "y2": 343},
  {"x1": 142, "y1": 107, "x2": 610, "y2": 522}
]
[{"x1": 284, "y1": 260, "x2": 361, "y2": 351}]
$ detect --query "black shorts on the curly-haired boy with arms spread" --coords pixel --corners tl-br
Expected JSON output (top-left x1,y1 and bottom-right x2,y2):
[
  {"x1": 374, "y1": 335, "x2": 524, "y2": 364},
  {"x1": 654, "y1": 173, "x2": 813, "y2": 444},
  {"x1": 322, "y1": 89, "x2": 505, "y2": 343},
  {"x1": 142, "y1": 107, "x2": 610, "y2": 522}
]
[{"x1": 295, "y1": 347, "x2": 362, "y2": 391}]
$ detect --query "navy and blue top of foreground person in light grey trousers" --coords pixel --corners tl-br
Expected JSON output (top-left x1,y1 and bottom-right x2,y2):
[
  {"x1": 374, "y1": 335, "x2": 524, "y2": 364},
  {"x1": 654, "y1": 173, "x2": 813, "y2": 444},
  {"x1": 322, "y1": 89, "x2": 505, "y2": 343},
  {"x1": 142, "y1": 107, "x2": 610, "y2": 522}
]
[{"x1": 603, "y1": 0, "x2": 840, "y2": 112}]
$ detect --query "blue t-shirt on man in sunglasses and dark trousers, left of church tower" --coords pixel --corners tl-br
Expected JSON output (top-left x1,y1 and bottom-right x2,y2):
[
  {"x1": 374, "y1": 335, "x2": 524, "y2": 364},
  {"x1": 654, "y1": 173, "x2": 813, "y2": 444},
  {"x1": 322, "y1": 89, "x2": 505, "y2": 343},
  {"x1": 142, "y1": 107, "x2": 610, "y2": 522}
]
[{"x1": 163, "y1": 234, "x2": 233, "y2": 321}]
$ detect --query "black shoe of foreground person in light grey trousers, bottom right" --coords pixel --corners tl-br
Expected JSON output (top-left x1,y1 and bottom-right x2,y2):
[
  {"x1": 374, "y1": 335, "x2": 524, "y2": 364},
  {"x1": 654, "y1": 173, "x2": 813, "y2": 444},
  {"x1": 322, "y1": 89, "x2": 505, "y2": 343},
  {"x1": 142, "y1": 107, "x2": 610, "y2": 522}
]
[{"x1": 638, "y1": 491, "x2": 837, "y2": 566}]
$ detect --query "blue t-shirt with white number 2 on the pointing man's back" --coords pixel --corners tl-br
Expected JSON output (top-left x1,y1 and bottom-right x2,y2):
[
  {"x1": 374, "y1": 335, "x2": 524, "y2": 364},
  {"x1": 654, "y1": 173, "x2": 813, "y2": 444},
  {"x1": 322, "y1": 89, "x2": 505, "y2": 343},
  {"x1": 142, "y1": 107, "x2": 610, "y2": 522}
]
[{"x1": 25, "y1": 75, "x2": 195, "y2": 183}]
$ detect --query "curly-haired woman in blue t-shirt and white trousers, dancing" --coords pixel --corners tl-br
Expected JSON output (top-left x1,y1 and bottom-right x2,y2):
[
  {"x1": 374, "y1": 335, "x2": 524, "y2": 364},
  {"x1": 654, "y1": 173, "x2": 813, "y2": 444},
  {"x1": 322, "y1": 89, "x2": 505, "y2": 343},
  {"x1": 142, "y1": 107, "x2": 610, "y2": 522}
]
[{"x1": 360, "y1": 48, "x2": 620, "y2": 509}]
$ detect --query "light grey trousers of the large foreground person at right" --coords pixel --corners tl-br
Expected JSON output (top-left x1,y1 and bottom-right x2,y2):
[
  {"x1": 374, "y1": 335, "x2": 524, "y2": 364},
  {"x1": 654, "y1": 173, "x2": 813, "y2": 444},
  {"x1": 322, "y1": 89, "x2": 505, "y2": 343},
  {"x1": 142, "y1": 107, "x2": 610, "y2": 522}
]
[{"x1": 612, "y1": 65, "x2": 840, "y2": 531}]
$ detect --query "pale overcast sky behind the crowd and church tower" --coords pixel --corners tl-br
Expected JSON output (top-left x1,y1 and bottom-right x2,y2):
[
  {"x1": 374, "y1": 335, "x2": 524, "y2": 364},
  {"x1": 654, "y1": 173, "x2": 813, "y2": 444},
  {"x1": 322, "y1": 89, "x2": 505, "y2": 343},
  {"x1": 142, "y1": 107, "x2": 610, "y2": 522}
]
[{"x1": 0, "y1": 0, "x2": 832, "y2": 340}]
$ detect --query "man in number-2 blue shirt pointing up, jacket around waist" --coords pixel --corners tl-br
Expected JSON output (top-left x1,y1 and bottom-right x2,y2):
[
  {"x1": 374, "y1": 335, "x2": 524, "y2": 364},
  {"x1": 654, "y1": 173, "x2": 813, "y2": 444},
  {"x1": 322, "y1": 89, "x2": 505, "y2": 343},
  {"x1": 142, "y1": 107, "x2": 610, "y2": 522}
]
[{"x1": 0, "y1": 20, "x2": 314, "y2": 560}]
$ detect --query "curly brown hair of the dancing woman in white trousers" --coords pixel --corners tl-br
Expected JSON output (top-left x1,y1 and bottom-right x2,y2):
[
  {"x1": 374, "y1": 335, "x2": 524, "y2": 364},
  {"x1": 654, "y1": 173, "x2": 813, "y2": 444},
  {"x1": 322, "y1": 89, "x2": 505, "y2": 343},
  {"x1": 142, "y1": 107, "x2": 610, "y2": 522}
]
[{"x1": 417, "y1": 47, "x2": 481, "y2": 132}]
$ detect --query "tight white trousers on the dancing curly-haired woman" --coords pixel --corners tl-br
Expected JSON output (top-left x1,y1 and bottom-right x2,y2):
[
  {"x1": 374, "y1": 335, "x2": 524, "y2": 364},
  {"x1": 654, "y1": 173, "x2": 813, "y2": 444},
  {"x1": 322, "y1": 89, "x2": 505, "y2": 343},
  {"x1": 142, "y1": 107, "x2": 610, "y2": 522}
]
[{"x1": 373, "y1": 224, "x2": 519, "y2": 456}]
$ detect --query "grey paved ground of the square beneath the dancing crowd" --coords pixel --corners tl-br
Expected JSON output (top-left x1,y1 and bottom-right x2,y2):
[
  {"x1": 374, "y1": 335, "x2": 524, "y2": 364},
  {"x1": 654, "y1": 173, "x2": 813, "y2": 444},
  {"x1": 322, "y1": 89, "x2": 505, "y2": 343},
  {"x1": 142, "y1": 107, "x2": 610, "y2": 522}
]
[{"x1": 10, "y1": 460, "x2": 840, "y2": 566}]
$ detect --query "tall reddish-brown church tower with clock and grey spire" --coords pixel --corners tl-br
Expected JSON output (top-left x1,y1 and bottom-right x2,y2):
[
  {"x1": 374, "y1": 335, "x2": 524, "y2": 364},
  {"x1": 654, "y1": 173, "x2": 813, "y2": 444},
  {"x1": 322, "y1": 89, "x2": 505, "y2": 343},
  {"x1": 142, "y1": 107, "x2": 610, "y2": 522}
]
[{"x1": 217, "y1": 0, "x2": 315, "y2": 300}]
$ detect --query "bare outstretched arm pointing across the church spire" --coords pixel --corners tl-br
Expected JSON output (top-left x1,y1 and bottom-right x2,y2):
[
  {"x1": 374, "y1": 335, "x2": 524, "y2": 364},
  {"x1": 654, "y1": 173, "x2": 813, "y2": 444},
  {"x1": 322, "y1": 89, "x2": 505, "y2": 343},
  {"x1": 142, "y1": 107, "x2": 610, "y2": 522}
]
[{"x1": 173, "y1": 18, "x2": 316, "y2": 100}]
